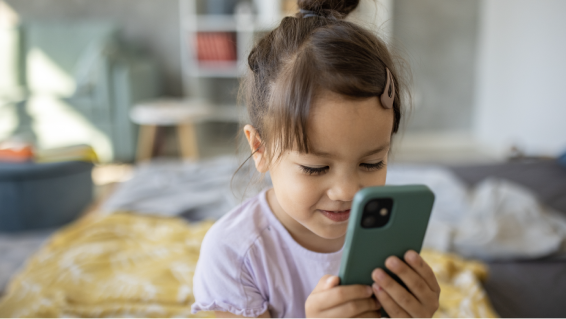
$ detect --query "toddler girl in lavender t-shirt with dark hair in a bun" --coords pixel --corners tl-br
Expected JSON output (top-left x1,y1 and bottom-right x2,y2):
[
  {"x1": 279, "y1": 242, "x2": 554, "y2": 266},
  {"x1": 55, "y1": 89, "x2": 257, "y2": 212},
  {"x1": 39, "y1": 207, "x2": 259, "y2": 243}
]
[{"x1": 192, "y1": 0, "x2": 440, "y2": 319}]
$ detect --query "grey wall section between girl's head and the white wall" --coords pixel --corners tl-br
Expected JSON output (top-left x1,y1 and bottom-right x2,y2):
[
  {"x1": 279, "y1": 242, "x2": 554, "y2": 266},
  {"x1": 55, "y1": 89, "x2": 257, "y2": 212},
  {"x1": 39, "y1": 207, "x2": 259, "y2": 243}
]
[{"x1": 393, "y1": 0, "x2": 480, "y2": 132}]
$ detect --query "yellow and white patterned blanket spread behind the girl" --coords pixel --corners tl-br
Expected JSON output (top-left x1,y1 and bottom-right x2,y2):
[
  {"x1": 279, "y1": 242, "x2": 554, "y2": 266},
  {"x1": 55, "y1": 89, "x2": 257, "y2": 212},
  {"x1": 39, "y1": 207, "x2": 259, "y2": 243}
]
[{"x1": 0, "y1": 213, "x2": 497, "y2": 319}]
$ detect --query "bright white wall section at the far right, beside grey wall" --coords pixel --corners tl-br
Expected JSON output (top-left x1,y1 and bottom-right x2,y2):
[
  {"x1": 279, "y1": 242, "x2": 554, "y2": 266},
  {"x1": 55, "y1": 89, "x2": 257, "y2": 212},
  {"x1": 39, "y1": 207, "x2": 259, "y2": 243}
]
[{"x1": 474, "y1": 0, "x2": 566, "y2": 155}]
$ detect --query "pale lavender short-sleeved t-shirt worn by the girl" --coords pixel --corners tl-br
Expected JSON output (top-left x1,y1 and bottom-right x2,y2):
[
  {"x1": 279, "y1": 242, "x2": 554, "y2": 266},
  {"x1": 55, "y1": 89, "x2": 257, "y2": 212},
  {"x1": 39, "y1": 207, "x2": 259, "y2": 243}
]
[{"x1": 192, "y1": 191, "x2": 342, "y2": 319}]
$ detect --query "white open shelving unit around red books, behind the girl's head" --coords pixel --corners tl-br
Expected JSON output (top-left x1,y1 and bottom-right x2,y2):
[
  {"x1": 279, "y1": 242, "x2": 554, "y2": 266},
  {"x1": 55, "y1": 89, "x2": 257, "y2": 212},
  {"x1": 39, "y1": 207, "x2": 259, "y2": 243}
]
[{"x1": 179, "y1": 0, "x2": 392, "y2": 121}]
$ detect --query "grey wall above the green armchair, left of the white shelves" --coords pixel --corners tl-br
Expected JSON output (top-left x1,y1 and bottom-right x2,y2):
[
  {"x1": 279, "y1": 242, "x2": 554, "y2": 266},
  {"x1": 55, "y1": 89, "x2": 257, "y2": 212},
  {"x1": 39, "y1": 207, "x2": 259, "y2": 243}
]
[{"x1": 4, "y1": 0, "x2": 182, "y2": 96}]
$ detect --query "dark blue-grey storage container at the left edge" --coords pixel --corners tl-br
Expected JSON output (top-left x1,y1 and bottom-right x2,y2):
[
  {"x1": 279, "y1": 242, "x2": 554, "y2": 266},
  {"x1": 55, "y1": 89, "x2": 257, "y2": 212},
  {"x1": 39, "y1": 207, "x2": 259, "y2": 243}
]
[{"x1": 0, "y1": 161, "x2": 93, "y2": 232}]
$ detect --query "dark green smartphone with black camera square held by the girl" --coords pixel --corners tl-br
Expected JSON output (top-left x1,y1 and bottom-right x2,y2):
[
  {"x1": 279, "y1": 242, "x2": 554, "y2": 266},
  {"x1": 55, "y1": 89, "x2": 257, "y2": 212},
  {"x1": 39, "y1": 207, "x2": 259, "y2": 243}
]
[{"x1": 339, "y1": 185, "x2": 434, "y2": 316}]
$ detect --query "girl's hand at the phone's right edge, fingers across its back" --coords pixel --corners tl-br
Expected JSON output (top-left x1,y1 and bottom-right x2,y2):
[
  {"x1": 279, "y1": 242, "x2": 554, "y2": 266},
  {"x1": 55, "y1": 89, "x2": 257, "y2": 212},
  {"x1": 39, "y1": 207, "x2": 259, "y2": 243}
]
[{"x1": 372, "y1": 250, "x2": 440, "y2": 319}]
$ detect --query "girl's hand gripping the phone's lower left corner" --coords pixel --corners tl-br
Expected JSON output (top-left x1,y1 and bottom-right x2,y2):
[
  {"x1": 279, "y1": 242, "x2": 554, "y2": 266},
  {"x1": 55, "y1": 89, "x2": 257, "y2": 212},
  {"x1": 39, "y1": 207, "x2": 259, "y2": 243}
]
[{"x1": 305, "y1": 275, "x2": 381, "y2": 319}]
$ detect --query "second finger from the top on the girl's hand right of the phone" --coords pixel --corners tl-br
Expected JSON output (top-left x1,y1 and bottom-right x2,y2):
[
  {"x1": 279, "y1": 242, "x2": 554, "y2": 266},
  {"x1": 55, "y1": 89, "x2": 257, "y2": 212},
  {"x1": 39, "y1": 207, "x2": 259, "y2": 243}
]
[{"x1": 385, "y1": 256, "x2": 438, "y2": 304}]
